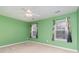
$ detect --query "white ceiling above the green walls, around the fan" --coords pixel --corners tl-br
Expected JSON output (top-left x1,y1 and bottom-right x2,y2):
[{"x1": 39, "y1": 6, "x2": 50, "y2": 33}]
[{"x1": 0, "y1": 6, "x2": 78, "y2": 22}]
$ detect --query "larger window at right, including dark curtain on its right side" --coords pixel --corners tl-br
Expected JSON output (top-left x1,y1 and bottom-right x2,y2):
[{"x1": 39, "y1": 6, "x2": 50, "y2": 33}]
[{"x1": 53, "y1": 18, "x2": 72, "y2": 42}]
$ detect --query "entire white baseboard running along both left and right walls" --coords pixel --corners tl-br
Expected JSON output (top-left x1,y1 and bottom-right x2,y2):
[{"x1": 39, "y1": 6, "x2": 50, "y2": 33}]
[{"x1": 0, "y1": 41, "x2": 78, "y2": 52}]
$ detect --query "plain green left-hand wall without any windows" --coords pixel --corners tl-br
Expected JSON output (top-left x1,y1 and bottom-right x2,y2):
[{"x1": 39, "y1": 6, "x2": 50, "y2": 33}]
[{"x1": 0, "y1": 15, "x2": 30, "y2": 46}]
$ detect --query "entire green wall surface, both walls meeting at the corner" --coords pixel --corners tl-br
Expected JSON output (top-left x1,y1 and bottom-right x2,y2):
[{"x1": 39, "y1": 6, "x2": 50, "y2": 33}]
[{"x1": 0, "y1": 11, "x2": 79, "y2": 50}]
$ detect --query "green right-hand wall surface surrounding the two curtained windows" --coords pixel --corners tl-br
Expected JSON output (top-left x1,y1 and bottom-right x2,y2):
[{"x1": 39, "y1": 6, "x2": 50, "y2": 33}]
[{"x1": 30, "y1": 12, "x2": 77, "y2": 50}]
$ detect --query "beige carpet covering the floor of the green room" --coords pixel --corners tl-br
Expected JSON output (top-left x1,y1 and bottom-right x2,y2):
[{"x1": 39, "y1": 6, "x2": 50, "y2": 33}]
[{"x1": 0, "y1": 42, "x2": 74, "y2": 53}]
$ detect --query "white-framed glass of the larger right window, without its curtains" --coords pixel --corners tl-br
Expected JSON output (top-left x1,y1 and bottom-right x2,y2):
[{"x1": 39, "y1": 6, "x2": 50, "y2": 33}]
[{"x1": 54, "y1": 18, "x2": 68, "y2": 41}]
